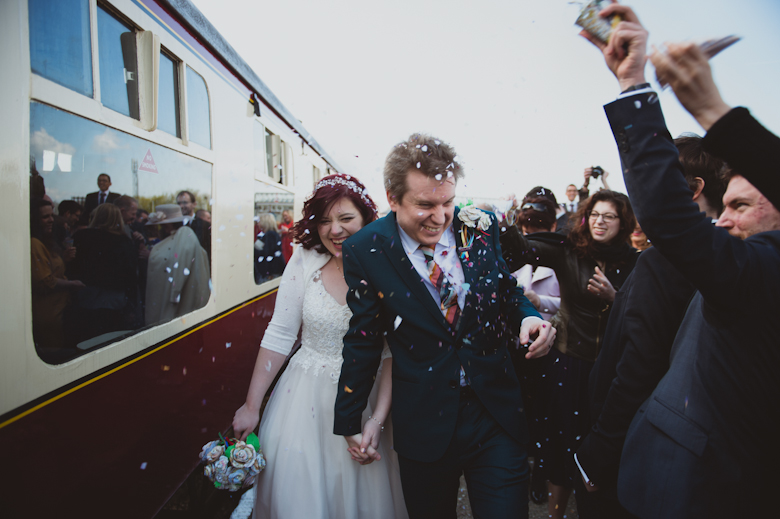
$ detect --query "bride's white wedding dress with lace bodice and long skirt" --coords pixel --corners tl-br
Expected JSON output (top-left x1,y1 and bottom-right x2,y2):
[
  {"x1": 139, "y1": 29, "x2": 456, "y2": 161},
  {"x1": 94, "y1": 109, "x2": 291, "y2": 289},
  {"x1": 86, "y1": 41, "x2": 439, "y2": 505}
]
[{"x1": 254, "y1": 247, "x2": 407, "y2": 519}]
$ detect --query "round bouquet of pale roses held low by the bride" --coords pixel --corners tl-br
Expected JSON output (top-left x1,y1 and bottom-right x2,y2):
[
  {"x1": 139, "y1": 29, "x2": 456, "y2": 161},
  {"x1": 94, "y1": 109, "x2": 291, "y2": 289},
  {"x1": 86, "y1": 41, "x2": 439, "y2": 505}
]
[{"x1": 200, "y1": 433, "x2": 265, "y2": 492}]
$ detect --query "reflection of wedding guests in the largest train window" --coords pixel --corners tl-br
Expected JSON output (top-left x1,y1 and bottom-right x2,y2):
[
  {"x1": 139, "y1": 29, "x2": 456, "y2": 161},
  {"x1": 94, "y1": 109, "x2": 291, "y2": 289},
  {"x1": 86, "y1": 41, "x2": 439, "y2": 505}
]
[{"x1": 30, "y1": 173, "x2": 211, "y2": 363}]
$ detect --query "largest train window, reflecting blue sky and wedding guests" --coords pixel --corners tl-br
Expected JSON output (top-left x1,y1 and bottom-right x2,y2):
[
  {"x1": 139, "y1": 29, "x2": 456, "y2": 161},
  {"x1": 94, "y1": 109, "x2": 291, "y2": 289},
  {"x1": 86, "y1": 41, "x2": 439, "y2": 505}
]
[{"x1": 30, "y1": 102, "x2": 212, "y2": 363}]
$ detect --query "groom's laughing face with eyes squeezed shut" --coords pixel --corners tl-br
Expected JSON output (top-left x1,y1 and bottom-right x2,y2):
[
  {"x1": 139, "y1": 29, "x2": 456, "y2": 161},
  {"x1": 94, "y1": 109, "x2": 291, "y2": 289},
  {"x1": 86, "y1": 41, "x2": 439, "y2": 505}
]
[{"x1": 387, "y1": 169, "x2": 455, "y2": 247}]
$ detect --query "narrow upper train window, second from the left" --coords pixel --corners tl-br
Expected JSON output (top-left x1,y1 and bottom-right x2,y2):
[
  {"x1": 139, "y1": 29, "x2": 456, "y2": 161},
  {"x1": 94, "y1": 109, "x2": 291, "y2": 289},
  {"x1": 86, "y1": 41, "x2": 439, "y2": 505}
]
[{"x1": 97, "y1": 6, "x2": 140, "y2": 119}]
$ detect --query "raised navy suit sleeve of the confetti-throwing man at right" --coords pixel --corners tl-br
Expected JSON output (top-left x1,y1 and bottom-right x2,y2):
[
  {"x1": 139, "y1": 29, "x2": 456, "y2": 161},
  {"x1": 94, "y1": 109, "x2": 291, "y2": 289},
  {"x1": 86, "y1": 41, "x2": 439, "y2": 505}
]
[{"x1": 605, "y1": 93, "x2": 778, "y2": 315}]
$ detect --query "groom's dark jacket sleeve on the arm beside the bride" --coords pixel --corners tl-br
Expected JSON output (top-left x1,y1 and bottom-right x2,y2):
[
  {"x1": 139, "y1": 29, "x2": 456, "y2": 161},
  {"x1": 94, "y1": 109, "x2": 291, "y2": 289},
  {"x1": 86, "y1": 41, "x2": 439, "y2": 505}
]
[{"x1": 333, "y1": 242, "x2": 384, "y2": 436}]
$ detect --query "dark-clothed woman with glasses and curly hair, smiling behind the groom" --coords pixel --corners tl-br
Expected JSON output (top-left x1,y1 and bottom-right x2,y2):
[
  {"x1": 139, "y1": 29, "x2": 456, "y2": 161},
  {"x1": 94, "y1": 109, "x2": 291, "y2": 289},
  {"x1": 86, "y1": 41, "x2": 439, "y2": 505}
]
[{"x1": 501, "y1": 190, "x2": 637, "y2": 518}]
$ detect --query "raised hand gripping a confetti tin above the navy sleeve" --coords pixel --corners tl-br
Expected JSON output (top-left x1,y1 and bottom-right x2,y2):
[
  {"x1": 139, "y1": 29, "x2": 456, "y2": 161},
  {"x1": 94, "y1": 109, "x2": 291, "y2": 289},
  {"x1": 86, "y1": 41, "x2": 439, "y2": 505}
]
[{"x1": 580, "y1": 4, "x2": 647, "y2": 91}]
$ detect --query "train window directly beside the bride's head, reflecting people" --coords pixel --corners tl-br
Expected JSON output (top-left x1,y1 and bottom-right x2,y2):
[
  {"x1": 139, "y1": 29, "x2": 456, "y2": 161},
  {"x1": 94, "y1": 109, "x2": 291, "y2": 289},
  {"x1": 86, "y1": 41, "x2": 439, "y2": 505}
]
[{"x1": 254, "y1": 182, "x2": 295, "y2": 285}]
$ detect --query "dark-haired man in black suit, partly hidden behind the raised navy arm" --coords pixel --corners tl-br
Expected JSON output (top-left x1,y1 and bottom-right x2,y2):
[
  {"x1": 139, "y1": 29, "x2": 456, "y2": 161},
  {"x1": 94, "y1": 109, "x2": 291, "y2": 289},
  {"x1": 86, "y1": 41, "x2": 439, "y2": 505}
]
[{"x1": 575, "y1": 135, "x2": 725, "y2": 518}]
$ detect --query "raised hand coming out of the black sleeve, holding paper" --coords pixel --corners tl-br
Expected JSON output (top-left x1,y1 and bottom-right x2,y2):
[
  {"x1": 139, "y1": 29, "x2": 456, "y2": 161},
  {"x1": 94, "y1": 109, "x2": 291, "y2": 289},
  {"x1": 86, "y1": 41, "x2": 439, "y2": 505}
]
[{"x1": 650, "y1": 42, "x2": 731, "y2": 130}]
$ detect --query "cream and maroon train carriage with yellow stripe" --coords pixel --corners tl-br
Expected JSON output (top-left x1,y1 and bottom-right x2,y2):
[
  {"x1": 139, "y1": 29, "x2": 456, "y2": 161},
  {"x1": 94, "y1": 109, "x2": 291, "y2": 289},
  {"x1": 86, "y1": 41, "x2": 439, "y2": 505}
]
[{"x1": 0, "y1": 0, "x2": 338, "y2": 518}]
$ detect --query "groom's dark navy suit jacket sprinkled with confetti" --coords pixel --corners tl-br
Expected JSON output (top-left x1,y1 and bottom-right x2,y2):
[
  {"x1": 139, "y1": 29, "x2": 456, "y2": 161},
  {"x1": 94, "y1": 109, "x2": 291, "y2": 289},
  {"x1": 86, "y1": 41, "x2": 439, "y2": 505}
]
[{"x1": 334, "y1": 209, "x2": 539, "y2": 462}]
